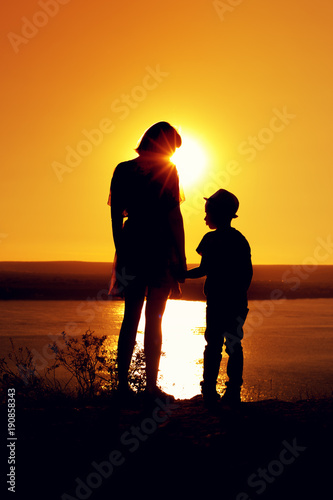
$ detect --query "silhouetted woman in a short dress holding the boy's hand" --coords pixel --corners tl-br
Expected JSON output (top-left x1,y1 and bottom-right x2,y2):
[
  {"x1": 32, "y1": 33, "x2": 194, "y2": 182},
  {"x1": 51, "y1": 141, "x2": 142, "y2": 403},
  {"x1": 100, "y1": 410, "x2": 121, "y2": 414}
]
[{"x1": 110, "y1": 122, "x2": 186, "y2": 398}]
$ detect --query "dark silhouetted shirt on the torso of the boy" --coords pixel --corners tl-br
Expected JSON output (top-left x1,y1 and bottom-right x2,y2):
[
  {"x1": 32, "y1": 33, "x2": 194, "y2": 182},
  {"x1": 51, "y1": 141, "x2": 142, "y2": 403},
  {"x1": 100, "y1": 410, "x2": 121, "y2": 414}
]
[{"x1": 197, "y1": 227, "x2": 253, "y2": 309}]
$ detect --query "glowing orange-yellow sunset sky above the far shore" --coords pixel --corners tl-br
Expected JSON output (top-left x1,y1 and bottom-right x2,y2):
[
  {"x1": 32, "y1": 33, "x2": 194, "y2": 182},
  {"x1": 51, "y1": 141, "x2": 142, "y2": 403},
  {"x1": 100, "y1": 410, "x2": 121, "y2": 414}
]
[{"x1": 0, "y1": 0, "x2": 333, "y2": 265}]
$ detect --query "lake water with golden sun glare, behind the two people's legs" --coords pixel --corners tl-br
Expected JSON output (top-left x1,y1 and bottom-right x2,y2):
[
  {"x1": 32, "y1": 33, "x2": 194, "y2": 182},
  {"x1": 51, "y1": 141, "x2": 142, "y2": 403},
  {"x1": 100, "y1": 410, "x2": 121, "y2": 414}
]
[{"x1": 0, "y1": 298, "x2": 333, "y2": 401}]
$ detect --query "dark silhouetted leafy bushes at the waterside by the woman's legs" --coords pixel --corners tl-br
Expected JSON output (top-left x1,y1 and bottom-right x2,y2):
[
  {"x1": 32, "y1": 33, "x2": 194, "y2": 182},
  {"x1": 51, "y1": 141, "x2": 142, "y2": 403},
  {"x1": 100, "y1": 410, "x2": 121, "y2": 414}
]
[{"x1": 0, "y1": 330, "x2": 146, "y2": 399}]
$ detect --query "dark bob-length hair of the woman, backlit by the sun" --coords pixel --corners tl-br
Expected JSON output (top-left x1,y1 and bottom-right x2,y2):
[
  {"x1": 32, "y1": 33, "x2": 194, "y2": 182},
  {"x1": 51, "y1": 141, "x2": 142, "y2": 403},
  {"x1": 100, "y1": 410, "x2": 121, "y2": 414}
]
[{"x1": 135, "y1": 122, "x2": 182, "y2": 156}]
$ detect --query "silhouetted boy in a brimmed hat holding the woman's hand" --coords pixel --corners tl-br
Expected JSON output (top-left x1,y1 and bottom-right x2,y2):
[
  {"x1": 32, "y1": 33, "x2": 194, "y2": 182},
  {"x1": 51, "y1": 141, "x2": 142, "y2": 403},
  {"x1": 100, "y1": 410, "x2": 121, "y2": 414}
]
[{"x1": 186, "y1": 189, "x2": 253, "y2": 406}]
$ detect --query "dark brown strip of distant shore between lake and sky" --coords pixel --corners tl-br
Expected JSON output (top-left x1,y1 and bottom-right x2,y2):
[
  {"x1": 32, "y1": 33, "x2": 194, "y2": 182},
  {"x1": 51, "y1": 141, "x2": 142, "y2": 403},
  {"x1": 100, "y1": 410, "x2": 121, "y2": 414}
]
[{"x1": 0, "y1": 261, "x2": 333, "y2": 301}]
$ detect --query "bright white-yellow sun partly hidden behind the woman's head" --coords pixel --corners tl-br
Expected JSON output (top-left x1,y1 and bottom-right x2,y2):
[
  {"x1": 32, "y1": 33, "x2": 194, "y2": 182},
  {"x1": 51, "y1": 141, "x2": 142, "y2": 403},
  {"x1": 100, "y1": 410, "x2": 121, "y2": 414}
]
[{"x1": 171, "y1": 134, "x2": 207, "y2": 187}]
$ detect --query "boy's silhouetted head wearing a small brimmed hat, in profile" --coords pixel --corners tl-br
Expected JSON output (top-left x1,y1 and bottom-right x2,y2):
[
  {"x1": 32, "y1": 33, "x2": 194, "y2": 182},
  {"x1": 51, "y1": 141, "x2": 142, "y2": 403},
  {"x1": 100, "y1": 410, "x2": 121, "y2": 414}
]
[{"x1": 204, "y1": 189, "x2": 239, "y2": 229}]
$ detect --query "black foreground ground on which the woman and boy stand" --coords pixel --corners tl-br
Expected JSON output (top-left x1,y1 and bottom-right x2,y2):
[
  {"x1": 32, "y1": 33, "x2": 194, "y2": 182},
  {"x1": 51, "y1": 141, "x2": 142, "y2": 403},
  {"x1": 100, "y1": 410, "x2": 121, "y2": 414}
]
[{"x1": 1, "y1": 396, "x2": 333, "y2": 500}]
